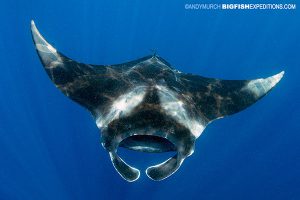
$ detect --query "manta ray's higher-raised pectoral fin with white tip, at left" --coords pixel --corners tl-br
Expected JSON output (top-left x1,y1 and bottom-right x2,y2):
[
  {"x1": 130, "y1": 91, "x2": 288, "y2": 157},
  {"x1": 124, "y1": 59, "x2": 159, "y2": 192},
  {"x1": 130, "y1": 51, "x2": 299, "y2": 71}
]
[{"x1": 31, "y1": 21, "x2": 117, "y2": 111}]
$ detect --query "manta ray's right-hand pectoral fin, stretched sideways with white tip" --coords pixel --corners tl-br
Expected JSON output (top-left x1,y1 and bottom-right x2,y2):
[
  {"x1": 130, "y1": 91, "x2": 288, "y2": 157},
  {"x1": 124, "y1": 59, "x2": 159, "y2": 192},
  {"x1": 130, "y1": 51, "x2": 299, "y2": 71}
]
[{"x1": 182, "y1": 71, "x2": 284, "y2": 121}]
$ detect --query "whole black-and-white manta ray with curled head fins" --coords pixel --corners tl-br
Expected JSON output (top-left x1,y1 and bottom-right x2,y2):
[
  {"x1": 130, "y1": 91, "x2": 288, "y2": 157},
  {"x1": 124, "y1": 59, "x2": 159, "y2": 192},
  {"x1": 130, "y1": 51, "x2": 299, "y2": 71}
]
[{"x1": 31, "y1": 21, "x2": 284, "y2": 182}]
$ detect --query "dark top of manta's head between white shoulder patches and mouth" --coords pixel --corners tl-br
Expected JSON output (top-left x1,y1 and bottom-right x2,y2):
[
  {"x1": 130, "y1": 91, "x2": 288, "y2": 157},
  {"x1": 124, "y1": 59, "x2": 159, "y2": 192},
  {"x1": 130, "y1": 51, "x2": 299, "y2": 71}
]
[{"x1": 102, "y1": 89, "x2": 195, "y2": 155}]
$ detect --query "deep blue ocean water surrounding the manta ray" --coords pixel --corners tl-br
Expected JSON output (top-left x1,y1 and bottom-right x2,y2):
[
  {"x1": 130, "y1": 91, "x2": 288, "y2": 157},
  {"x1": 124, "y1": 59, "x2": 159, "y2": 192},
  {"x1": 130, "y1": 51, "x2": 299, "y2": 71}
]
[{"x1": 0, "y1": 0, "x2": 300, "y2": 200}]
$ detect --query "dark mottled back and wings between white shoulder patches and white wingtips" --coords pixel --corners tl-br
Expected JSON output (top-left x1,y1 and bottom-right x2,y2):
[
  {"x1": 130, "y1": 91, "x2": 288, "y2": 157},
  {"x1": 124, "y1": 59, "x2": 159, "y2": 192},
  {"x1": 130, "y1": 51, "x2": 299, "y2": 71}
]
[{"x1": 39, "y1": 52, "x2": 258, "y2": 121}]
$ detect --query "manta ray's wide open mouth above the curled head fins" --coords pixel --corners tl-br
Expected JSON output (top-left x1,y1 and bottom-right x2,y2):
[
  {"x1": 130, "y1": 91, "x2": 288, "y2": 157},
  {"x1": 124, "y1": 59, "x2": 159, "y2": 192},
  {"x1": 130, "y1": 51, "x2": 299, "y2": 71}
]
[{"x1": 119, "y1": 135, "x2": 176, "y2": 153}]
